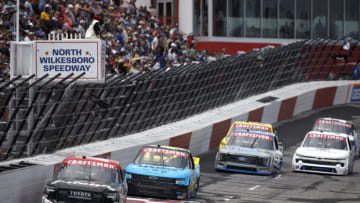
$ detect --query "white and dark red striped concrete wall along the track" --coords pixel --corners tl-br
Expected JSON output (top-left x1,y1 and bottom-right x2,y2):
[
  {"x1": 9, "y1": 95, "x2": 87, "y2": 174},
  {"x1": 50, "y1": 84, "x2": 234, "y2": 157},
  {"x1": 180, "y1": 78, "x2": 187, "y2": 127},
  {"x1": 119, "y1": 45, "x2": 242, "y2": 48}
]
[{"x1": 0, "y1": 81, "x2": 360, "y2": 203}]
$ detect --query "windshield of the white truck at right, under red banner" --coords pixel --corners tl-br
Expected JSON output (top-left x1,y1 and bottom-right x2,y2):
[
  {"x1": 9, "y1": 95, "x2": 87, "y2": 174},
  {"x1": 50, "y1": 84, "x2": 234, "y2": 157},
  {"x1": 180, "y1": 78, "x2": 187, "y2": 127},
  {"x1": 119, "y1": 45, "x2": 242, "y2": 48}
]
[{"x1": 303, "y1": 134, "x2": 347, "y2": 150}]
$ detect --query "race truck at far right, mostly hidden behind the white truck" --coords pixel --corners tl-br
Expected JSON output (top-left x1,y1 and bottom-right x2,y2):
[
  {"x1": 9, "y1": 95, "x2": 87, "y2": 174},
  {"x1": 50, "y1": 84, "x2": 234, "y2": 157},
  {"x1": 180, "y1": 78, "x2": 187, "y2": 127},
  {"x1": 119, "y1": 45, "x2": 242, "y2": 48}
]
[{"x1": 312, "y1": 118, "x2": 359, "y2": 156}]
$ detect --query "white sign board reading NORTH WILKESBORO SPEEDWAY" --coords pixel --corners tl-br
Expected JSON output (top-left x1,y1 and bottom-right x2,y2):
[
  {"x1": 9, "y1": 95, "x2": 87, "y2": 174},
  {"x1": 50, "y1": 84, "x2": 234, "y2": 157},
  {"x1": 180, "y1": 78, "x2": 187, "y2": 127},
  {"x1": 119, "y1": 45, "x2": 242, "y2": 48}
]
[{"x1": 33, "y1": 40, "x2": 105, "y2": 81}]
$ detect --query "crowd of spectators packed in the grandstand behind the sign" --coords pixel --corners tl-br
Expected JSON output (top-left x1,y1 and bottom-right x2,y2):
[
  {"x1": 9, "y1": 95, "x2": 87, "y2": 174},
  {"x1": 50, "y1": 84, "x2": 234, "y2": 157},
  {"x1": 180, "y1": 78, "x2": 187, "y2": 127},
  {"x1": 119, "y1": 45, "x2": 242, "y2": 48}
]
[{"x1": 0, "y1": 0, "x2": 228, "y2": 76}]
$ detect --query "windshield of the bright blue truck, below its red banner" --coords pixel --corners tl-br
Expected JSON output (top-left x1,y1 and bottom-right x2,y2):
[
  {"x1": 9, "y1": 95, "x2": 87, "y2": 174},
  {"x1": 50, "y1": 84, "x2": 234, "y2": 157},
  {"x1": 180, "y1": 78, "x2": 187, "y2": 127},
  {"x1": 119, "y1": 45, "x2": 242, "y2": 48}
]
[{"x1": 134, "y1": 147, "x2": 189, "y2": 169}]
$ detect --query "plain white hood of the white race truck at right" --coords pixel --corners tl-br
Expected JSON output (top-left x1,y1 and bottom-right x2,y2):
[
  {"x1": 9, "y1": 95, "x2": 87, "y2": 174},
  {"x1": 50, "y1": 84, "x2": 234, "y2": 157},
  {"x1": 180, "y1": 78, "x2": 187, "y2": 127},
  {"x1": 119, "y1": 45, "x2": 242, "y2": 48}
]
[{"x1": 296, "y1": 147, "x2": 349, "y2": 159}]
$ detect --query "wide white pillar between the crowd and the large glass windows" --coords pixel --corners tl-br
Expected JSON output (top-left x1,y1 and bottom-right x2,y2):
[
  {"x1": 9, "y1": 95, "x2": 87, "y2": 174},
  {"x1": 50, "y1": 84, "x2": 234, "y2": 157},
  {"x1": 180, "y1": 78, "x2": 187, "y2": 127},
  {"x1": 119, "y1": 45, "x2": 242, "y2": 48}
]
[{"x1": 179, "y1": 0, "x2": 193, "y2": 34}]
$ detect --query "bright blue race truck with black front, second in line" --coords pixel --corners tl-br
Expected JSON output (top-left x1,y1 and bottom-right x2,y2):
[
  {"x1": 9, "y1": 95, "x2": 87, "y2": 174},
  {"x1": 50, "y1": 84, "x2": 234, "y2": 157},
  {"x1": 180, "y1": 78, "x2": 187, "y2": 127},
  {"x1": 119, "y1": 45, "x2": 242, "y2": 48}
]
[{"x1": 125, "y1": 145, "x2": 200, "y2": 199}]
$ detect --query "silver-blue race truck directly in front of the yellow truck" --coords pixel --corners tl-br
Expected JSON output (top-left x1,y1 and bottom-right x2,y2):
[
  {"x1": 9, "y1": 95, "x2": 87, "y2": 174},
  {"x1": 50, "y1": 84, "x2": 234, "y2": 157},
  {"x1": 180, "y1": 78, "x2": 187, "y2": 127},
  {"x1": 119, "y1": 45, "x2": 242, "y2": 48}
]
[{"x1": 215, "y1": 130, "x2": 283, "y2": 175}]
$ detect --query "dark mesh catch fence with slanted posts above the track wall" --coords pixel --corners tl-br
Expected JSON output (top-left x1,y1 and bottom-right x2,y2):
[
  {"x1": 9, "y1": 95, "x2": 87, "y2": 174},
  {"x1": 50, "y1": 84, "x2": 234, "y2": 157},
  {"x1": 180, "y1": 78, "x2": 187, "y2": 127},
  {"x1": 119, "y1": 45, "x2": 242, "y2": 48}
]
[{"x1": 0, "y1": 40, "x2": 360, "y2": 160}]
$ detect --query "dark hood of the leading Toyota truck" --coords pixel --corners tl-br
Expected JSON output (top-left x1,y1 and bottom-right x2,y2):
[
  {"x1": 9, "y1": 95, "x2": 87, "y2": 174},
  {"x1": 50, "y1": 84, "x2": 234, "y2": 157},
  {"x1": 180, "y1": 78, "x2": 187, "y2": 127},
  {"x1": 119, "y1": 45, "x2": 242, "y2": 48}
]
[{"x1": 48, "y1": 180, "x2": 119, "y2": 193}]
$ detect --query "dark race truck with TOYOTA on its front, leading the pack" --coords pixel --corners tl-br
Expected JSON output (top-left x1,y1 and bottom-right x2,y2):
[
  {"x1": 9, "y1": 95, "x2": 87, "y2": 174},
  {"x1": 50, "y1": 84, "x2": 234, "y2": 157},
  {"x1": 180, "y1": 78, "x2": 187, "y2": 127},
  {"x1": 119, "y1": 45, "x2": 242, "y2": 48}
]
[{"x1": 42, "y1": 157, "x2": 128, "y2": 203}]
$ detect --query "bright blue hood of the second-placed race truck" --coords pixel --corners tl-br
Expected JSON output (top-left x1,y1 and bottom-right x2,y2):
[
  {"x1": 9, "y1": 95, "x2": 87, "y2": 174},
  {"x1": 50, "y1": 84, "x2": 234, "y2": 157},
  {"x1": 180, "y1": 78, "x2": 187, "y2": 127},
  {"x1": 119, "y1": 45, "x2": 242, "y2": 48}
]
[{"x1": 126, "y1": 163, "x2": 191, "y2": 178}]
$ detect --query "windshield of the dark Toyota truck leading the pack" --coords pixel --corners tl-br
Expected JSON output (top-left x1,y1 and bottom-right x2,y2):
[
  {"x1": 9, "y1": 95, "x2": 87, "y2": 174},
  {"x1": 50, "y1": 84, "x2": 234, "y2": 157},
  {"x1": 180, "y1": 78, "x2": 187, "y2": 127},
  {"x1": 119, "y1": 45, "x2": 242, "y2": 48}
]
[{"x1": 57, "y1": 164, "x2": 118, "y2": 183}]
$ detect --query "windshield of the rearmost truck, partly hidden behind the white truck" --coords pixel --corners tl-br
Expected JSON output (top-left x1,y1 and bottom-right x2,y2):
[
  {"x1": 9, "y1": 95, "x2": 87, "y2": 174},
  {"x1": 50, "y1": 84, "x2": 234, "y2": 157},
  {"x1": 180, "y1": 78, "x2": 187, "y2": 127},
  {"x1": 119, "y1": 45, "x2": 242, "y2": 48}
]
[{"x1": 313, "y1": 120, "x2": 352, "y2": 135}]
